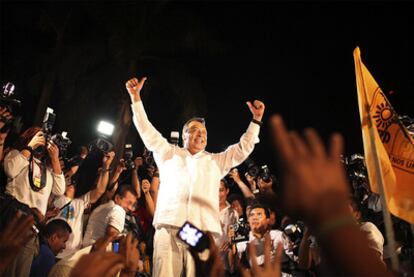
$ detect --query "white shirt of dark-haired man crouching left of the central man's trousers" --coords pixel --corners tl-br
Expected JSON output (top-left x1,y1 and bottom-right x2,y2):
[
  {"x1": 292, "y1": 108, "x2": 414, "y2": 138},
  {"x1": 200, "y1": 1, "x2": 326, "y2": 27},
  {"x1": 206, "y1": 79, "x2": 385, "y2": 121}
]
[{"x1": 82, "y1": 200, "x2": 125, "y2": 247}]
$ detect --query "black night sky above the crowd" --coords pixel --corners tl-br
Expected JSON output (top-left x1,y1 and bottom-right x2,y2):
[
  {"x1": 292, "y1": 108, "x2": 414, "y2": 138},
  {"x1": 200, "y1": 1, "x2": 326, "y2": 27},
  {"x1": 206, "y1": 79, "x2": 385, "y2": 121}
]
[{"x1": 0, "y1": 1, "x2": 414, "y2": 178}]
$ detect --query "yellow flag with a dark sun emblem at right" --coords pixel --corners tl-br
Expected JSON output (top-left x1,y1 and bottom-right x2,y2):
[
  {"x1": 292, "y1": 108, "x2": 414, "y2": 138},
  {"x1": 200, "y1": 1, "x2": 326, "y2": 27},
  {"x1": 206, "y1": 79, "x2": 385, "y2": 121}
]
[{"x1": 354, "y1": 47, "x2": 414, "y2": 224}]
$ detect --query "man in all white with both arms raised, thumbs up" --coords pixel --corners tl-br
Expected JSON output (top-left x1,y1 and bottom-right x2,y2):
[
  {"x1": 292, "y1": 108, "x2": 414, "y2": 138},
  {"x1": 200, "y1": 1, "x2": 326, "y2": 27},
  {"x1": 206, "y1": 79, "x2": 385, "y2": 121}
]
[{"x1": 126, "y1": 77, "x2": 265, "y2": 276}]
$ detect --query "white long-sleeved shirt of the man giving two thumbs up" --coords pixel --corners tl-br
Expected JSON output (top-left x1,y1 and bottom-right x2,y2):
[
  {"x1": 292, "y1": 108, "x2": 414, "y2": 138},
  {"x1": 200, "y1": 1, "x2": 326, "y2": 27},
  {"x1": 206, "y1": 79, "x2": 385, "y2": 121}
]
[{"x1": 131, "y1": 101, "x2": 260, "y2": 234}]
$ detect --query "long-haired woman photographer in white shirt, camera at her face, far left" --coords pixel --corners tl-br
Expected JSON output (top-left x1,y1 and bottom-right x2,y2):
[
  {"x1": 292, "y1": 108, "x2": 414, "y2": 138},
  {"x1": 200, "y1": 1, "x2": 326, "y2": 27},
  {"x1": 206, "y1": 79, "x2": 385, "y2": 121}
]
[{"x1": 1, "y1": 127, "x2": 65, "y2": 276}]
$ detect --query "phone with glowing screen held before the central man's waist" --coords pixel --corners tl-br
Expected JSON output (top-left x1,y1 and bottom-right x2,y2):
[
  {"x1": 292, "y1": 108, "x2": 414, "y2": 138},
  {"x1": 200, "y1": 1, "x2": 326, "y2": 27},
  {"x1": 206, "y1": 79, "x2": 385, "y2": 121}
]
[{"x1": 177, "y1": 221, "x2": 210, "y2": 252}]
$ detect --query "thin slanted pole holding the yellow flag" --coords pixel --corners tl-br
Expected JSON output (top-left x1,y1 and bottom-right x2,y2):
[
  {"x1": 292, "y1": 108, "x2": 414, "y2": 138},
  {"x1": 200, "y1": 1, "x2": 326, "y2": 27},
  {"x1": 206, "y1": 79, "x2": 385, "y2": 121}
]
[{"x1": 357, "y1": 49, "x2": 399, "y2": 272}]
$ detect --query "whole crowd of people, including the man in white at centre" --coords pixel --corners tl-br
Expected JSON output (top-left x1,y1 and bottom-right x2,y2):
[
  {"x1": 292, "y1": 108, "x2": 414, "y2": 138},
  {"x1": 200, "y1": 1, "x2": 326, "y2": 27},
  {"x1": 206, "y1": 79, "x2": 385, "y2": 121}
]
[{"x1": 0, "y1": 74, "x2": 408, "y2": 276}]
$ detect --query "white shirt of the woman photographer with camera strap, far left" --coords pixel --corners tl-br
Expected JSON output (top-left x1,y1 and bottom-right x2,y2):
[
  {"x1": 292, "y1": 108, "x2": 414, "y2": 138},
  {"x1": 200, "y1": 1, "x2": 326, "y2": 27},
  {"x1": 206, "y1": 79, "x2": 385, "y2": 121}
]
[{"x1": 4, "y1": 149, "x2": 66, "y2": 215}]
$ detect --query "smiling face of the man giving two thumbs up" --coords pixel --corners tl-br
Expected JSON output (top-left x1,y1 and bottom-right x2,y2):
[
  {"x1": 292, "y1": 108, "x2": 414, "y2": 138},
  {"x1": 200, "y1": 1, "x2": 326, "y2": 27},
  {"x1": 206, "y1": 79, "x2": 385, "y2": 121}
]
[{"x1": 183, "y1": 121, "x2": 207, "y2": 155}]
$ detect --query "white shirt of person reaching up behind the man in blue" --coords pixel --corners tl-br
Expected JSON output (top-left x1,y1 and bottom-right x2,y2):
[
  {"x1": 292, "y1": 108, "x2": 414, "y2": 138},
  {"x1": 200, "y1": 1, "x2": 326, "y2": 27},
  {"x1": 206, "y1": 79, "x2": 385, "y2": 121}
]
[{"x1": 54, "y1": 192, "x2": 90, "y2": 259}]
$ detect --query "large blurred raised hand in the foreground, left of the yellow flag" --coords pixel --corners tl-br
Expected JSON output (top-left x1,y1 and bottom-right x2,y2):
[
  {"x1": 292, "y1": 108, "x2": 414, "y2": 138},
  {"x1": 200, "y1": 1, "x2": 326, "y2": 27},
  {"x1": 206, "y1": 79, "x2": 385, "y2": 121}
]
[{"x1": 271, "y1": 116, "x2": 349, "y2": 220}]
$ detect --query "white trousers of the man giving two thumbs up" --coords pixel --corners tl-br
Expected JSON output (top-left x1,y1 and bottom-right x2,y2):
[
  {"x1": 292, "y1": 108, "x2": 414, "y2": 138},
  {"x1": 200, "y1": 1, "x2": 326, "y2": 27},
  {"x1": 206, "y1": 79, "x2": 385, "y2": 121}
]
[{"x1": 152, "y1": 227, "x2": 195, "y2": 277}]
